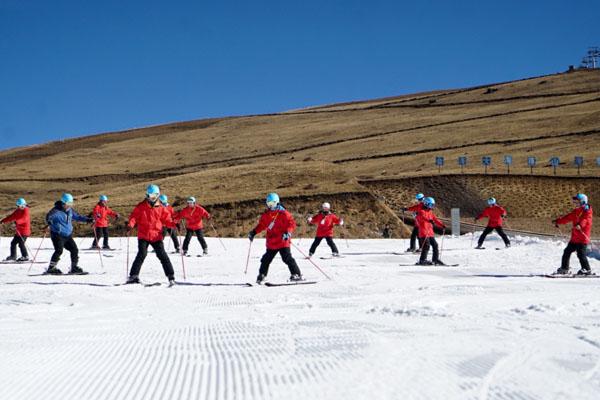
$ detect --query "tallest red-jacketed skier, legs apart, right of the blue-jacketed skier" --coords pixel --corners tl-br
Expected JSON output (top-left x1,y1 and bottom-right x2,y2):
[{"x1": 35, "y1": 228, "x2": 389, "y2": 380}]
[{"x1": 126, "y1": 185, "x2": 175, "y2": 286}]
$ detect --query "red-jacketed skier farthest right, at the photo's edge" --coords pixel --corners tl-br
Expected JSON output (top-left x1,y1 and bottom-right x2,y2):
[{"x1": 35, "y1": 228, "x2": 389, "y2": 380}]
[{"x1": 552, "y1": 193, "x2": 593, "y2": 275}]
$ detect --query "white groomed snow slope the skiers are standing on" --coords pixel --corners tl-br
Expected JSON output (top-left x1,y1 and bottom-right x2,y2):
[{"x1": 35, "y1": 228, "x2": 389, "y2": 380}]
[{"x1": 0, "y1": 235, "x2": 600, "y2": 400}]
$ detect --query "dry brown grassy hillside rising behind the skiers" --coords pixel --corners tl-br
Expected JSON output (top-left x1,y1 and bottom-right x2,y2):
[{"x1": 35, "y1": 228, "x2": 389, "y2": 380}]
[{"x1": 0, "y1": 70, "x2": 600, "y2": 237}]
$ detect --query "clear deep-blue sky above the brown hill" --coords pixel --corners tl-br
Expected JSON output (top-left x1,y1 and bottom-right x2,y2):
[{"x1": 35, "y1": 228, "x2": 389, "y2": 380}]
[{"x1": 0, "y1": 0, "x2": 600, "y2": 149}]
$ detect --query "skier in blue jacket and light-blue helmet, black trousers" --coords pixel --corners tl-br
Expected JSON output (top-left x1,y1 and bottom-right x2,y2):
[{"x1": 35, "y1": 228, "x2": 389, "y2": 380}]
[{"x1": 45, "y1": 193, "x2": 94, "y2": 275}]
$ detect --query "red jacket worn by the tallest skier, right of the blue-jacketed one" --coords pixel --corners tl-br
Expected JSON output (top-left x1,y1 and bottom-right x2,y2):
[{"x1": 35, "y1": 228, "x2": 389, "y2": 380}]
[{"x1": 128, "y1": 200, "x2": 173, "y2": 243}]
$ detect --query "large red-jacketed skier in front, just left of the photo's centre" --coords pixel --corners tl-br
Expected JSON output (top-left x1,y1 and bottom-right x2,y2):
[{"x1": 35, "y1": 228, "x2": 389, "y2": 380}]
[{"x1": 248, "y1": 193, "x2": 303, "y2": 285}]
